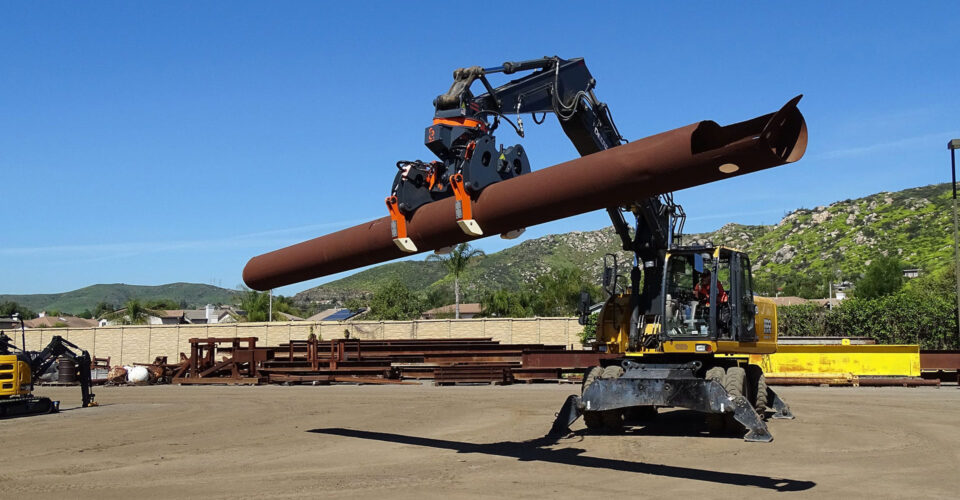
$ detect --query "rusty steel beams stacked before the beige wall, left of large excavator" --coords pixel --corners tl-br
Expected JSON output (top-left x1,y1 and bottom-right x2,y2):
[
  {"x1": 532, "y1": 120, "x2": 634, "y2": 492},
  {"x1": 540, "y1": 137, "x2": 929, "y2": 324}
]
[{"x1": 173, "y1": 338, "x2": 604, "y2": 385}]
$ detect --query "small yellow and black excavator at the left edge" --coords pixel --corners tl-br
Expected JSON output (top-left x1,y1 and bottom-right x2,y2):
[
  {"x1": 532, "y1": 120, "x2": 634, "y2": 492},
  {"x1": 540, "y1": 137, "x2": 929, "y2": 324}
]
[{"x1": 0, "y1": 316, "x2": 97, "y2": 418}]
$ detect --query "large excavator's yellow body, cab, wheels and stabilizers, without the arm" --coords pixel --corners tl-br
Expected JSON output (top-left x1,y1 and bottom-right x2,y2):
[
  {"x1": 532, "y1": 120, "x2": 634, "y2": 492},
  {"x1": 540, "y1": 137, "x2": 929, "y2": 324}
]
[{"x1": 551, "y1": 240, "x2": 793, "y2": 442}]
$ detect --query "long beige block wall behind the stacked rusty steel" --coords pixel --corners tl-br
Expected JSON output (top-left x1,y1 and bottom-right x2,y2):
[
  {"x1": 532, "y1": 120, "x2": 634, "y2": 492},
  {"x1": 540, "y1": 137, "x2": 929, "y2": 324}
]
[{"x1": 7, "y1": 318, "x2": 583, "y2": 365}]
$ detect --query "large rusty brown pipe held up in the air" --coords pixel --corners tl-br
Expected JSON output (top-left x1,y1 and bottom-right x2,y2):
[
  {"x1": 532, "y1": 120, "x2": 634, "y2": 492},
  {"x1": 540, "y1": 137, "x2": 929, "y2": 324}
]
[{"x1": 243, "y1": 96, "x2": 807, "y2": 290}]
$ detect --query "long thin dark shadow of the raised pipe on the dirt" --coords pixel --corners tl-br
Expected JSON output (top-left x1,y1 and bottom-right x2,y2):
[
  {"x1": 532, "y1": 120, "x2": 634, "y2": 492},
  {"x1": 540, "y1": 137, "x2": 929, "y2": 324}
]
[{"x1": 307, "y1": 428, "x2": 816, "y2": 491}]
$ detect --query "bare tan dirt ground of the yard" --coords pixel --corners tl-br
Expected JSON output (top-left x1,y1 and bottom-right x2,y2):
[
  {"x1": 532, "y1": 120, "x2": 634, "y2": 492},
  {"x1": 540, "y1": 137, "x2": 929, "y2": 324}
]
[{"x1": 0, "y1": 385, "x2": 960, "y2": 500}]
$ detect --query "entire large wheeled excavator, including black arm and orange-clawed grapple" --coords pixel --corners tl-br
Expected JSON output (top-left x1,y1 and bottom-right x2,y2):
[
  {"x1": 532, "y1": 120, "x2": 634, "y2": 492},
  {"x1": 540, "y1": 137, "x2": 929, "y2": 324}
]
[{"x1": 386, "y1": 57, "x2": 800, "y2": 441}]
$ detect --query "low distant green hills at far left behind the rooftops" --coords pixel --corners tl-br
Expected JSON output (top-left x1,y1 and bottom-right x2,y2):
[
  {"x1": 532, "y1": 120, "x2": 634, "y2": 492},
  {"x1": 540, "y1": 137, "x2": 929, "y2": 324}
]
[{"x1": 0, "y1": 283, "x2": 237, "y2": 314}]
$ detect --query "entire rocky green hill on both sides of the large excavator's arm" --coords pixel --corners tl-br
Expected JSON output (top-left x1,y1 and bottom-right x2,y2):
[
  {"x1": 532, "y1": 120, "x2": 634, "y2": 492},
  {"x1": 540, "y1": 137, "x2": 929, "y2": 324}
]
[{"x1": 294, "y1": 184, "x2": 953, "y2": 304}]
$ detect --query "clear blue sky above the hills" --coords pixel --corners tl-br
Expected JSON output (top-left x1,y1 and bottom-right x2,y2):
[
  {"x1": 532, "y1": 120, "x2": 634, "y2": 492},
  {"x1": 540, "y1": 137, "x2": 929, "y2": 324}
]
[{"x1": 0, "y1": 1, "x2": 960, "y2": 295}]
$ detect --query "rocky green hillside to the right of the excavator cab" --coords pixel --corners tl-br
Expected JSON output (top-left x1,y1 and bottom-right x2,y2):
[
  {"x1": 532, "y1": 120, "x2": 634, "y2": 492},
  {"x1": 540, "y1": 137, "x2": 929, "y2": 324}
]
[{"x1": 687, "y1": 184, "x2": 953, "y2": 278}]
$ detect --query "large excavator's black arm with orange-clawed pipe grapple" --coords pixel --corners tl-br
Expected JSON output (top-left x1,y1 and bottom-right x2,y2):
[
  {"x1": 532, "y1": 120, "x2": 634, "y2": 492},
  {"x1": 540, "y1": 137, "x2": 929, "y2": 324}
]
[{"x1": 387, "y1": 57, "x2": 684, "y2": 274}]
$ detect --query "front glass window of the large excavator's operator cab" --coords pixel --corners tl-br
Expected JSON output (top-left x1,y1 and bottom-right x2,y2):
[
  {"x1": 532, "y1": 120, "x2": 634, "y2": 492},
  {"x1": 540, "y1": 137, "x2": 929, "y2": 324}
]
[{"x1": 664, "y1": 254, "x2": 711, "y2": 337}]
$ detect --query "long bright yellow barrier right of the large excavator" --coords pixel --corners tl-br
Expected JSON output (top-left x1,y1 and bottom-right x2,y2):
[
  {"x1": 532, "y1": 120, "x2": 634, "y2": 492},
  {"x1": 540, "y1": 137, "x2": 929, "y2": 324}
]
[{"x1": 750, "y1": 341, "x2": 920, "y2": 378}]
